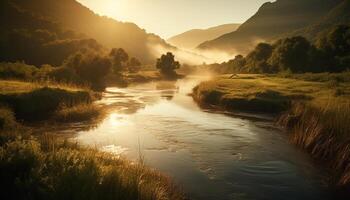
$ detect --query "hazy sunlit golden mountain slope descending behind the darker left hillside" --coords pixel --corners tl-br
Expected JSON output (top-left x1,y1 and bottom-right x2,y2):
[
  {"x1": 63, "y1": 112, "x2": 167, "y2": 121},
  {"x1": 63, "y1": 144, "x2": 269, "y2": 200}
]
[{"x1": 8, "y1": 0, "x2": 175, "y2": 63}]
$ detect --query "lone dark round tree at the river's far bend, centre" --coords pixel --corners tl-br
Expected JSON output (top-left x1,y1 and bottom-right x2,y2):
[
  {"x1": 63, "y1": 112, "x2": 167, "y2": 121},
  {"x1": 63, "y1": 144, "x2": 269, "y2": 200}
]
[{"x1": 156, "y1": 52, "x2": 180, "y2": 75}]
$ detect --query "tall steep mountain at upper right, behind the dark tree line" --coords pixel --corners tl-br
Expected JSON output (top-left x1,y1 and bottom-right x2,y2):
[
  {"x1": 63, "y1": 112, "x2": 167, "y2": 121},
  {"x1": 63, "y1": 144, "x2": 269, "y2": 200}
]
[{"x1": 198, "y1": 0, "x2": 344, "y2": 54}]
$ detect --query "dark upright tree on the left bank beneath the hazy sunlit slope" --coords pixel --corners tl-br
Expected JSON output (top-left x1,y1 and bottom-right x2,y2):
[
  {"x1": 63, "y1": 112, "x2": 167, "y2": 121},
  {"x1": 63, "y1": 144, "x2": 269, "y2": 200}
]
[{"x1": 109, "y1": 48, "x2": 129, "y2": 74}]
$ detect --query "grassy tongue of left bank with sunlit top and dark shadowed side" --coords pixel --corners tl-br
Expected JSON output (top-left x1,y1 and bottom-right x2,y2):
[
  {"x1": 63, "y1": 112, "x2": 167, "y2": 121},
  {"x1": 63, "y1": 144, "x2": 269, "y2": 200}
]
[{"x1": 0, "y1": 80, "x2": 94, "y2": 121}]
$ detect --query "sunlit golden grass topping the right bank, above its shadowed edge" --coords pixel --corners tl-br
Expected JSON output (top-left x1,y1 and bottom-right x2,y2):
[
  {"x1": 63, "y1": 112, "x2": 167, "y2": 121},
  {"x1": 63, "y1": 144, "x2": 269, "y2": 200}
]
[{"x1": 194, "y1": 74, "x2": 350, "y2": 112}]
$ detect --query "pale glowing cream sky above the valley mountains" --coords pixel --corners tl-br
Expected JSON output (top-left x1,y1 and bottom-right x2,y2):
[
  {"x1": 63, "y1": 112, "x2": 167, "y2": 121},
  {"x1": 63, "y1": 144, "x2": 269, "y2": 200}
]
[{"x1": 78, "y1": 0, "x2": 269, "y2": 39}]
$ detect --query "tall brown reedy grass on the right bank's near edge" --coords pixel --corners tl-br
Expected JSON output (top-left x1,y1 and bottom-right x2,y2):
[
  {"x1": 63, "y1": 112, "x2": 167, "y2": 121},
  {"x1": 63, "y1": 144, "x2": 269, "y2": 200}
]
[{"x1": 279, "y1": 99, "x2": 350, "y2": 192}]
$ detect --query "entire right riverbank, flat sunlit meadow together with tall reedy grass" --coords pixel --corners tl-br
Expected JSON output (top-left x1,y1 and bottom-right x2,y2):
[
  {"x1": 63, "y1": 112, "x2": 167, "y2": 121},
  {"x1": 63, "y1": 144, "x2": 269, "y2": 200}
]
[{"x1": 193, "y1": 74, "x2": 350, "y2": 195}]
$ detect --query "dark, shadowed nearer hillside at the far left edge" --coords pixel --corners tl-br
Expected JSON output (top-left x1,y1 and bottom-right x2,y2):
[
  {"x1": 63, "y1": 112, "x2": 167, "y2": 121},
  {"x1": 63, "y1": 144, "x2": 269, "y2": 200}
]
[{"x1": 0, "y1": 0, "x2": 103, "y2": 66}]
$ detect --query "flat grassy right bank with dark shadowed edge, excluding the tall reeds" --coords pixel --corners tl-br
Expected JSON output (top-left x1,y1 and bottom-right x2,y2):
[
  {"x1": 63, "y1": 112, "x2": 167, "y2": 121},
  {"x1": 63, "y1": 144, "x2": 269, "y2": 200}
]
[{"x1": 193, "y1": 75, "x2": 350, "y2": 113}]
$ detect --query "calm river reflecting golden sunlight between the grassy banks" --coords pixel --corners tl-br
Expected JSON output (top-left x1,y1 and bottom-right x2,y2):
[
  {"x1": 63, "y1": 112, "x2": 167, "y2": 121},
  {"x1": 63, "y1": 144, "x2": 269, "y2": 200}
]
[{"x1": 74, "y1": 77, "x2": 329, "y2": 200}]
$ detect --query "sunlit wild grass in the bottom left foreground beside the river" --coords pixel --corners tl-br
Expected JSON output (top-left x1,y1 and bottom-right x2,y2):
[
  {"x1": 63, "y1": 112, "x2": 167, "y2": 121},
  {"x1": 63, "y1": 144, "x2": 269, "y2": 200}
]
[{"x1": 0, "y1": 137, "x2": 184, "y2": 200}]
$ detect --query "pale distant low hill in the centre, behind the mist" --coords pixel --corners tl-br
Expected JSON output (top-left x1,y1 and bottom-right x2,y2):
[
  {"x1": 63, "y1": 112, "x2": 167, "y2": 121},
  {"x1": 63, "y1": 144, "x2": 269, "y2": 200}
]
[{"x1": 167, "y1": 24, "x2": 240, "y2": 49}]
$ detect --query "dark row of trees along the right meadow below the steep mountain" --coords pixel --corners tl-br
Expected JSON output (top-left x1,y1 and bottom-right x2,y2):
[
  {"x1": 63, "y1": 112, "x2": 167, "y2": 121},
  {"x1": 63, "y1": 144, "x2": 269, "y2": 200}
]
[{"x1": 211, "y1": 25, "x2": 350, "y2": 73}]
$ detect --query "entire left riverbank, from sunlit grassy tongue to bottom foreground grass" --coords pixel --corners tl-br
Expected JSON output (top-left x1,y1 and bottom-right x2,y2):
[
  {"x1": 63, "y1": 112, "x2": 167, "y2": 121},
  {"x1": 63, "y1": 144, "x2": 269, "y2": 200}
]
[{"x1": 0, "y1": 80, "x2": 184, "y2": 200}]
